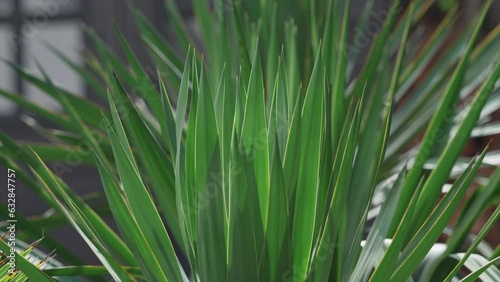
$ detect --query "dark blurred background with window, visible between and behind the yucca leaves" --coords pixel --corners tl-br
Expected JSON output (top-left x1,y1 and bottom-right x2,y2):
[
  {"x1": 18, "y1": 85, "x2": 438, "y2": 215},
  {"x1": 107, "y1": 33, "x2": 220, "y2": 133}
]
[{"x1": 0, "y1": 0, "x2": 500, "y2": 263}]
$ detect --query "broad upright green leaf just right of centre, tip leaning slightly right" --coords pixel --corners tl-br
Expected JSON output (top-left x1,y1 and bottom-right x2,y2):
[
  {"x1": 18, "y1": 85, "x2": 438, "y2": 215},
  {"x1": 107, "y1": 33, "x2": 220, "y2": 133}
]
[{"x1": 292, "y1": 46, "x2": 326, "y2": 279}]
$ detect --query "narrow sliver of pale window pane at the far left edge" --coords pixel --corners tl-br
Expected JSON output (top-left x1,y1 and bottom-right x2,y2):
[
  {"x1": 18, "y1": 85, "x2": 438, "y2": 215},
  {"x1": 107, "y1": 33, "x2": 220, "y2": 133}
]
[{"x1": 0, "y1": 26, "x2": 17, "y2": 116}]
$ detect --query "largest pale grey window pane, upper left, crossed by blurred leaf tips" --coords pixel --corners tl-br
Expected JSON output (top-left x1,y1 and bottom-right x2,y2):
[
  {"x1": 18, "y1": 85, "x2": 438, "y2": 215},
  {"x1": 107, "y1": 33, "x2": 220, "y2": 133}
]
[{"x1": 25, "y1": 21, "x2": 84, "y2": 110}]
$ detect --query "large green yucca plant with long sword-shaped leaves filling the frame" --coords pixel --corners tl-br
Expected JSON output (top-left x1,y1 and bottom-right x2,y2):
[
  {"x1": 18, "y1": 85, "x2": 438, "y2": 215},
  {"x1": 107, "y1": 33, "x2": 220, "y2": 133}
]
[{"x1": 0, "y1": 0, "x2": 500, "y2": 282}]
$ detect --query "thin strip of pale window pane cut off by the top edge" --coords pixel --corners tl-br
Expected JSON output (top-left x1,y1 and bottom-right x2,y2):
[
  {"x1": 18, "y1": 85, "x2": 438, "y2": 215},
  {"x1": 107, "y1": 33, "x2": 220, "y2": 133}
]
[{"x1": 21, "y1": 0, "x2": 80, "y2": 14}]
